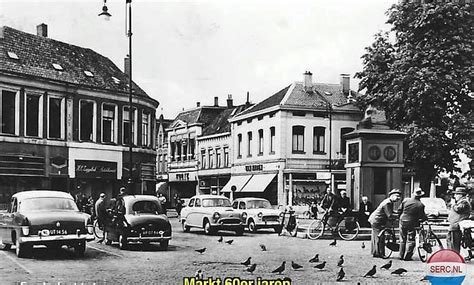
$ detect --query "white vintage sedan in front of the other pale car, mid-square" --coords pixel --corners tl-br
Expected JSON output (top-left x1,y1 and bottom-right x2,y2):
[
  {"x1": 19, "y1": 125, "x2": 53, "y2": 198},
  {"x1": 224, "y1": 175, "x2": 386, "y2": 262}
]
[{"x1": 181, "y1": 195, "x2": 247, "y2": 235}]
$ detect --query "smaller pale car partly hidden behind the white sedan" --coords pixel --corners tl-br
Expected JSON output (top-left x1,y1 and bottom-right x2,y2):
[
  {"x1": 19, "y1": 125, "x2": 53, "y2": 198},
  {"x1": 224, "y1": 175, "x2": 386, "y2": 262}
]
[{"x1": 232, "y1": 198, "x2": 282, "y2": 233}]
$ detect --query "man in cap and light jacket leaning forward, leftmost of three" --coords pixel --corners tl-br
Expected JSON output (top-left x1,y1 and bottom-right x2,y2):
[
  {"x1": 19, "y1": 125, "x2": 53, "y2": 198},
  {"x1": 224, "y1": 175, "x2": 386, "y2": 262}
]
[{"x1": 369, "y1": 189, "x2": 402, "y2": 257}]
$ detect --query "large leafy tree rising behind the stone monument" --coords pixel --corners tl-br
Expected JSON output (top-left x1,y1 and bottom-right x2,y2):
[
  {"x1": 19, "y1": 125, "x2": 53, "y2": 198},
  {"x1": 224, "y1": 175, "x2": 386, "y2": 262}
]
[{"x1": 355, "y1": 1, "x2": 474, "y2": 192}]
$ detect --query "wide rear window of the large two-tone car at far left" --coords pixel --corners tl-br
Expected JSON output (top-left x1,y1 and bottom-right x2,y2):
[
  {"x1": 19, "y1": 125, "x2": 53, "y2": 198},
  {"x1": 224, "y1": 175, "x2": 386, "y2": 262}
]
[{"x1": 19, "y1": 197, "x2": 79, "y2": 212}]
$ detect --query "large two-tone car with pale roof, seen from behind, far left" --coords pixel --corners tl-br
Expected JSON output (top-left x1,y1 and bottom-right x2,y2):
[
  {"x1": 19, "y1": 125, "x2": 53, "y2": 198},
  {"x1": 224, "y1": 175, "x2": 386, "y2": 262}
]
[{"x1": 0, "y1": 190, "x2": 94, "y2": 257}]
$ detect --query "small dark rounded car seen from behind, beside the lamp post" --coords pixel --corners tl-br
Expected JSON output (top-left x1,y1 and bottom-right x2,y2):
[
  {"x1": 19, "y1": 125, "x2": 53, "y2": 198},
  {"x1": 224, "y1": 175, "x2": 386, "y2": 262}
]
[{"x1": 104, "y1": 195, "x2": 171, "y2": 250}]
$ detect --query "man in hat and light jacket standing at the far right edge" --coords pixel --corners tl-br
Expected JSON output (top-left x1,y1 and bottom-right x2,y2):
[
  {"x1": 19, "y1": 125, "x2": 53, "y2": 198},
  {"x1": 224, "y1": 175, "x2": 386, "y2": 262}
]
[{"x1": 448, "y1": 187, "x2": 471, "y2": 252}]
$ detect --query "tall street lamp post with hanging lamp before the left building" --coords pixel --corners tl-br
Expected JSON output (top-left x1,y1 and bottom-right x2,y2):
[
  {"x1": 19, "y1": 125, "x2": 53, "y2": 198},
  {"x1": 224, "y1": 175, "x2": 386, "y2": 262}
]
[{"x1": 99, "y1": 0, "x2": 133, "y2": 194}]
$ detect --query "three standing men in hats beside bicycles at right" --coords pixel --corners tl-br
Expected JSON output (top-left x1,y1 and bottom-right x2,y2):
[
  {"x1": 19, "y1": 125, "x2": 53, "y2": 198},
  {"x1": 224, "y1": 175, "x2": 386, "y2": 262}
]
[{"x1": 369, "y1": 187, "x2": 471, "y2": 260}]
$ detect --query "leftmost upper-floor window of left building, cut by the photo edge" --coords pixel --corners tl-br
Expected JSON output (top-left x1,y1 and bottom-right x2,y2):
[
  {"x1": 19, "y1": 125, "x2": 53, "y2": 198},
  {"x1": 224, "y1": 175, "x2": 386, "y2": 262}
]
[{"x1": 0, "y1": 90, "x2": 20, "y2": 135}]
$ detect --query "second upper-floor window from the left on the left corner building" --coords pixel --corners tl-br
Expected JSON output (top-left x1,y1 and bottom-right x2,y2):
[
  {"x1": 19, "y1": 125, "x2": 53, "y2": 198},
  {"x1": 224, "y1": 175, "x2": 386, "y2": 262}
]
[{"x1": 25, "y1": 94, "x2": 43, "y2": 137}]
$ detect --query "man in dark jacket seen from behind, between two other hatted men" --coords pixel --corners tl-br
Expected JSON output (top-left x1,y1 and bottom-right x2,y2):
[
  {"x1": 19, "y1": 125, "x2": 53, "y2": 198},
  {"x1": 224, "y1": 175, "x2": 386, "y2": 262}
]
[{"x1": 398, "y1": 188, "x2": 428, "y2": 260}]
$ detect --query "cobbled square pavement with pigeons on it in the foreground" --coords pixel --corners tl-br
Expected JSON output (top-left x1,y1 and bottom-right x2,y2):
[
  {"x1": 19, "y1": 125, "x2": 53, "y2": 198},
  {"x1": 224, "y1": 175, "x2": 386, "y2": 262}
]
[{"x1": 0, "y1": 218, "x2": 474, "y2": 285}]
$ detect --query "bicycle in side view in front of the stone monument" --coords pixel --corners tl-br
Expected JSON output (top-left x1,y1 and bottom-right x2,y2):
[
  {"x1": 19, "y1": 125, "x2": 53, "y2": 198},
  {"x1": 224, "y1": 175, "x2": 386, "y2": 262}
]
[{"x1": 306, "y1": 209, "x2": 360, "y2": 240}]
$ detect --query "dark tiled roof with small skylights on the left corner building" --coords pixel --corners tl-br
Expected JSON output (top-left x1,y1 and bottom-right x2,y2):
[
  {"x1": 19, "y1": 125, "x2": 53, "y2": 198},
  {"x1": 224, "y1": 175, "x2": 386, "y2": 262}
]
[{"x1": 0, "y1": 26, "x2": 156, "y2": 101}]
